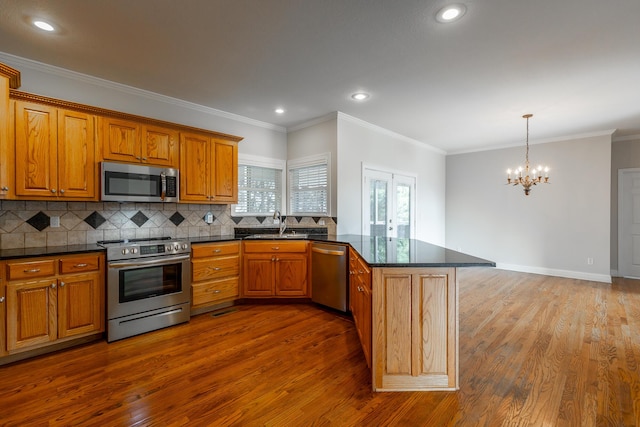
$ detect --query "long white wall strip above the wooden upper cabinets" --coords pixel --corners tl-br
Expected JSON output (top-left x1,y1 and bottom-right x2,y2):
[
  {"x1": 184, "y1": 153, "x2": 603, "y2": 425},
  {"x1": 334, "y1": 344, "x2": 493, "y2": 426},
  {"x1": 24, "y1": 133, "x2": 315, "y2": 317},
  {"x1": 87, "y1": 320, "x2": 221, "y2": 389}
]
[{"x1": 0, "y1": 52, "x2": 287, "y2": 159}]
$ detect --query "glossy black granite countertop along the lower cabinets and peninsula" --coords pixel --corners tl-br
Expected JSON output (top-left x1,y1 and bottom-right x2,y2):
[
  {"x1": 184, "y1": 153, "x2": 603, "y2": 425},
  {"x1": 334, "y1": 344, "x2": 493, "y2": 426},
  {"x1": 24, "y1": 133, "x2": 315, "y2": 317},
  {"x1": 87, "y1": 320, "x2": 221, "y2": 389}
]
[{"x1": 0, "y1": 234, "x2": 496, "y2": 267}]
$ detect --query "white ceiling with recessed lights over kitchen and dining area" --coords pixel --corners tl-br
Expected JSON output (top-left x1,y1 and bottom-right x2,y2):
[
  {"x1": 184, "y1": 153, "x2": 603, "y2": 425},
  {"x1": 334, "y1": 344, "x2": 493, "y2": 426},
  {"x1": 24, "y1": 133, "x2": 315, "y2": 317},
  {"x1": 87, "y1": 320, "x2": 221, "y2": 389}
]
[{"x1": 0, "y1": 0, "x2": 640, "y2": 153}]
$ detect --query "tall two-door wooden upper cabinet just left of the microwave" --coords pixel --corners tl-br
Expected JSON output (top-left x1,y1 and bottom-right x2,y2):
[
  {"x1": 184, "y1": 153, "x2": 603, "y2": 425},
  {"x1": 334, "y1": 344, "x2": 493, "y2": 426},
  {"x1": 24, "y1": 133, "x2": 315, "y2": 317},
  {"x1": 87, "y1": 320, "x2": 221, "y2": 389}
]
[{"x1": 15, "y1": 101, "x2": 97, "y2": 200}]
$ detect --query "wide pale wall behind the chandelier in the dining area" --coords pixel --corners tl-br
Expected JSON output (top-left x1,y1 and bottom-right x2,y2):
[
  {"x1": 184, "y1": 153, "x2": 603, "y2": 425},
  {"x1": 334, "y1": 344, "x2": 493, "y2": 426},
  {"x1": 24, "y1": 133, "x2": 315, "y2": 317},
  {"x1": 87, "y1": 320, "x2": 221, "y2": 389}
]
[{"x1": 446, "y1": 135, "x2": 611, "y2": 282}]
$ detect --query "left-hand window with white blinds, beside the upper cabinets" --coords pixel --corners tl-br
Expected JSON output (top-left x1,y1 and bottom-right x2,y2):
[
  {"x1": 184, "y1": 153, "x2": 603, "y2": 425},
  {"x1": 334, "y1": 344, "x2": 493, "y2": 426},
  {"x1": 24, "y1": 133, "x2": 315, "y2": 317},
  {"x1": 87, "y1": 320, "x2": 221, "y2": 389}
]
[{"x1": 231, "y1": 155, "x2": 285, "y2": 216}]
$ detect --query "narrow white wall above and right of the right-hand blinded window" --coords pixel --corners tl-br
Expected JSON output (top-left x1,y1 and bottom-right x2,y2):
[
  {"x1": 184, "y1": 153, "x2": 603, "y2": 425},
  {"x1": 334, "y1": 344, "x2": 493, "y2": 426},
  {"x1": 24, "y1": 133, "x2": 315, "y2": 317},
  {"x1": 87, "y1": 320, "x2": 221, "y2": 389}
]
[{"x1": 287, "y1": 113, "x2": 338, "y2": 217}]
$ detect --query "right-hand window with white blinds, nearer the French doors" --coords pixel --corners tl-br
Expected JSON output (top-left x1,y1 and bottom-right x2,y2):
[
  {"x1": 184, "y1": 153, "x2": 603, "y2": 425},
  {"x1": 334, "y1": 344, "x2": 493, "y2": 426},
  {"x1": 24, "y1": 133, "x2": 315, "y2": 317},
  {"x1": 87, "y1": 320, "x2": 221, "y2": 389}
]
[{"x1": 288, "y1": 154, "x2": 329, "y2": 215}]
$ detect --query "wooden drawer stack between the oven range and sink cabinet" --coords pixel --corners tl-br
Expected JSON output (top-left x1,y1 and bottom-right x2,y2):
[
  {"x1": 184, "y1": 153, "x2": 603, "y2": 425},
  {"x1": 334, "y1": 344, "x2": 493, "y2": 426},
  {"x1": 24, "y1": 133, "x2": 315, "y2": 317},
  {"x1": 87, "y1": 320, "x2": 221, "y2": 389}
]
[{"x1": 191, "y1": 241, "x2": 240, "y2": 309}]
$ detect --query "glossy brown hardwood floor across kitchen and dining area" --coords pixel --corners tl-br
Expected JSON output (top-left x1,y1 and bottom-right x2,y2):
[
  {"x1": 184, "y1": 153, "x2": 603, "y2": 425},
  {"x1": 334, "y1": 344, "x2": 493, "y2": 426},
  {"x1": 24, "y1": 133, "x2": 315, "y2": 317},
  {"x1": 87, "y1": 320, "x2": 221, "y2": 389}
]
[{"x1": 0, "y1": 268, "x2": 640, "y2": 426}]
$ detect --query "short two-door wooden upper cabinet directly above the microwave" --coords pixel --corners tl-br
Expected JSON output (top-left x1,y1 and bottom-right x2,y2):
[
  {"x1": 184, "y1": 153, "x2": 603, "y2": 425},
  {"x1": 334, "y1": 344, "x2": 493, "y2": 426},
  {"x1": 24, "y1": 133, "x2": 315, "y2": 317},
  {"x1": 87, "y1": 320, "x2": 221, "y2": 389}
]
[{"x1": 101, "y1": 117, "x2": 178, "y2": 168}]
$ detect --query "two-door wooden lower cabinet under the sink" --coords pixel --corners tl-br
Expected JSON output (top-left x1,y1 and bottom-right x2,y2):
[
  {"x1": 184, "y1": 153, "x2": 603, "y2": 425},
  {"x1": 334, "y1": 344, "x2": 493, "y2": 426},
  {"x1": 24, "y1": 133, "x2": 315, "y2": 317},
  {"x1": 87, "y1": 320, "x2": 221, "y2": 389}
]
[{"x1": 242, "y1": 240, "x2": 309, "y2": 297}]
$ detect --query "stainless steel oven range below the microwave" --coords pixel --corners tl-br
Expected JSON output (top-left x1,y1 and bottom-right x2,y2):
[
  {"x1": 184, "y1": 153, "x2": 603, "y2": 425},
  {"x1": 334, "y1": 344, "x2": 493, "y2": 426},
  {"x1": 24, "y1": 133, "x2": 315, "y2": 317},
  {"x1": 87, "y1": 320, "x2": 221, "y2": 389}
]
[{"x1": 98, "y1": 237, "x2": 191, "y2": 342}]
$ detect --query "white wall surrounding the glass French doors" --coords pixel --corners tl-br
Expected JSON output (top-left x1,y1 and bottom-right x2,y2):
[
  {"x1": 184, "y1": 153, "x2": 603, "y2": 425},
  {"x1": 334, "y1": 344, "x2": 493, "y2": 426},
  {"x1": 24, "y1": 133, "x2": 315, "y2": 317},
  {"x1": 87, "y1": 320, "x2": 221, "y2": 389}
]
[{"x1": 337, "y1": 113, "x2": 445, "y2": 245}]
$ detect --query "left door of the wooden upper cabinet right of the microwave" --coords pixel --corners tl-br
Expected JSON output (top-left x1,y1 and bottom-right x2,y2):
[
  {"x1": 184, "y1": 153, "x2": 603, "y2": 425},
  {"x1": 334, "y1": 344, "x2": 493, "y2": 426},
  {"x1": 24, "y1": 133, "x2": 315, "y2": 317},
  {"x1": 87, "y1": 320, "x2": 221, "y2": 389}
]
[{"x1": 180, "y1": 133, "x2": 212, "y2": 202}]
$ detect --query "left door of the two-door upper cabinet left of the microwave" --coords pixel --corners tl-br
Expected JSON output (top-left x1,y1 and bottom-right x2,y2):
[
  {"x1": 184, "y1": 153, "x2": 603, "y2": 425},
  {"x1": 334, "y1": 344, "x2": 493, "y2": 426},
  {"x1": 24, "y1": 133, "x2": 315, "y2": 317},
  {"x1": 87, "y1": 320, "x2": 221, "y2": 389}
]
[{"x1": 15, "y1": 101, "x2": 58, "y2": 197}]
